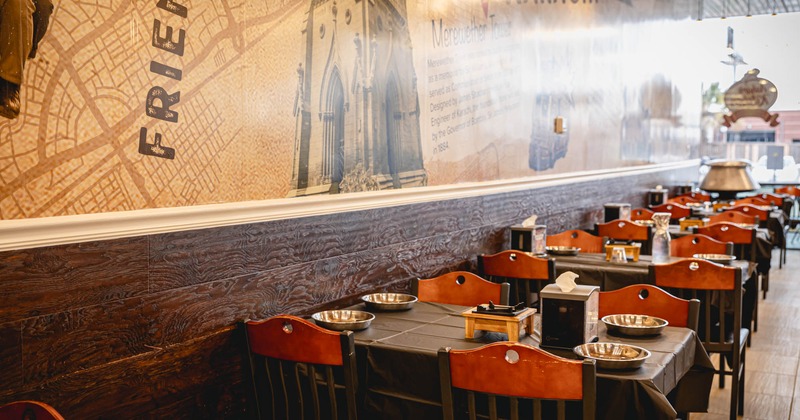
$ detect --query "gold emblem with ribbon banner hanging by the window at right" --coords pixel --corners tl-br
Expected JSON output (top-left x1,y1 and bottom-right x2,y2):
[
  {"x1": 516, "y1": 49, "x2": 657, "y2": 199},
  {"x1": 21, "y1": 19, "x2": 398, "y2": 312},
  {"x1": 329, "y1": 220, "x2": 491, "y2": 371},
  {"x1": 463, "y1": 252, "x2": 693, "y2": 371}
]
[{"x1": 722, "y1": 69, "x2": 779, "y2": 127}]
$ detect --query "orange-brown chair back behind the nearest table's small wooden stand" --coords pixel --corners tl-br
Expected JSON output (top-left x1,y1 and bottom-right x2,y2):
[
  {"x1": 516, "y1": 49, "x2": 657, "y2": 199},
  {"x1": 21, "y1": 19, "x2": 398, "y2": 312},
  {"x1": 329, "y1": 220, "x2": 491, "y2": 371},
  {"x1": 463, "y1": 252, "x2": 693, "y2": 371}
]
[{"x1": 411, "y1": 271, "x2": 510, "y2": 306}]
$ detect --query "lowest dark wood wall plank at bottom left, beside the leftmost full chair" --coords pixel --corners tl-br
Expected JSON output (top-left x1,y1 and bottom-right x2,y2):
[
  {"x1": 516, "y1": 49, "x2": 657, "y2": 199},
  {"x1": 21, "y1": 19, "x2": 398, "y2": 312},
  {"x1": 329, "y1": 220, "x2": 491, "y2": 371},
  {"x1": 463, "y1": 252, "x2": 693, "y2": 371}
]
[{"x1": 0, "y1": 328, "x2": 245, "y2": 419}]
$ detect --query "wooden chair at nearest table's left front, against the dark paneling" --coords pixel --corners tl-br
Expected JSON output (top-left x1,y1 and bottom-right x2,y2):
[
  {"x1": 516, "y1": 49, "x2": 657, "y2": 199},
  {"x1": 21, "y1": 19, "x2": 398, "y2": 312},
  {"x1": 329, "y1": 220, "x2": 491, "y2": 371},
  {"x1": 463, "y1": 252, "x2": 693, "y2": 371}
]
[{"x1": 243, "y1": 315, "x2": 357, "y2": 419}]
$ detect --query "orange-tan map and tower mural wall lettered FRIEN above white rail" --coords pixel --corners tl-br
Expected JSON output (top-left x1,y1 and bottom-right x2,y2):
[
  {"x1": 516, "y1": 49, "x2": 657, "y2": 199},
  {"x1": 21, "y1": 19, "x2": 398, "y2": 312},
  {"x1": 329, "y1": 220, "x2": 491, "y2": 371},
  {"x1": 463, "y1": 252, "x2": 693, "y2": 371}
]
[{"x1": 0, "y1": 0, "x2": 701, "y2": 219}]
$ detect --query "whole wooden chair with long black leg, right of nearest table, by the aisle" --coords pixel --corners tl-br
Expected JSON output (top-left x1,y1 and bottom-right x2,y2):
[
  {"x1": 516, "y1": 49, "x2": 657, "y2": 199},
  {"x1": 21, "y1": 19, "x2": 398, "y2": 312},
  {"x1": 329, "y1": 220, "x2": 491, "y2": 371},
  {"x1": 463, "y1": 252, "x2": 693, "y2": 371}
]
[{"x1": 649, "y1": 258, "x2": 750, "y2": 419}]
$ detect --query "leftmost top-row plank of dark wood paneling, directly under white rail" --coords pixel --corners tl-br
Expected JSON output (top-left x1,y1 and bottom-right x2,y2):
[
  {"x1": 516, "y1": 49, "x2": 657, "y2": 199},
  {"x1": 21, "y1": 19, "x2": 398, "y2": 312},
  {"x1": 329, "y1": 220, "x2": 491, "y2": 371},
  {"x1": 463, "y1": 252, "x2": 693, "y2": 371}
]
[{"x1": 0, "y1": 238, "x2": 147, "y2": 323}]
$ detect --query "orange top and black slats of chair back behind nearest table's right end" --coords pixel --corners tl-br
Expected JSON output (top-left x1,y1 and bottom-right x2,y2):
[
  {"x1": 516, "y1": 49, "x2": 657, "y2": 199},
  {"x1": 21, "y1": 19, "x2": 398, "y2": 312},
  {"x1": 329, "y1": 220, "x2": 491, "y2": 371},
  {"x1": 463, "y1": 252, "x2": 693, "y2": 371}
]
[{"x1": 649, "y1": 258, "x2": 742, "y2": 360}]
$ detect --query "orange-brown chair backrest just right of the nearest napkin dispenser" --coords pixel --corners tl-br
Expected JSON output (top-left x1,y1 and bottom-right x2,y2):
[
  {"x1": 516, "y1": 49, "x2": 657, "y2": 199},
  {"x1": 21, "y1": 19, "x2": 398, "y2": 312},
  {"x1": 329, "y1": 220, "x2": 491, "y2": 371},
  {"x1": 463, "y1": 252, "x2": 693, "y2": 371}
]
[{"x1": 598, "y1": 284, "x2": 700, "y2": 331}]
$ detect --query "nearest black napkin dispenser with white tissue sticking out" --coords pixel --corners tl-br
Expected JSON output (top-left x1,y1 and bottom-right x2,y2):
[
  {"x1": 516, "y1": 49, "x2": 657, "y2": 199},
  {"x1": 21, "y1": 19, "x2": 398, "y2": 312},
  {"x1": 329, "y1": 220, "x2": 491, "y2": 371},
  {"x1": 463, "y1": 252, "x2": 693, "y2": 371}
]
[{"x1": 540, "y1": 284, "x2": 600, "y2": 349}]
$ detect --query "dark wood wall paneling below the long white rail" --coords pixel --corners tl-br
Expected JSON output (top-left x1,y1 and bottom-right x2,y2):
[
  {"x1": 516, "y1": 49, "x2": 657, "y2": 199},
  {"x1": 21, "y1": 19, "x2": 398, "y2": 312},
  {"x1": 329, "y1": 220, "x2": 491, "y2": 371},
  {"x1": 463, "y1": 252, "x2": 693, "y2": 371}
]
[{"x1": 0, "y1": 170, "x2": 684, "y2": 419}]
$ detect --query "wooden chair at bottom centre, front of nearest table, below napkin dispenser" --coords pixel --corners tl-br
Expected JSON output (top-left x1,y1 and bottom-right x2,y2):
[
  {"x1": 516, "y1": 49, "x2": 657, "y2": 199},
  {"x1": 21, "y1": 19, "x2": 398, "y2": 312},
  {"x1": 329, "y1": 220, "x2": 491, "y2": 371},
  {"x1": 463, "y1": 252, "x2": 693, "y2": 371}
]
[{"x1": 439, "y1": 342, "x2": 597, "y2": 420}]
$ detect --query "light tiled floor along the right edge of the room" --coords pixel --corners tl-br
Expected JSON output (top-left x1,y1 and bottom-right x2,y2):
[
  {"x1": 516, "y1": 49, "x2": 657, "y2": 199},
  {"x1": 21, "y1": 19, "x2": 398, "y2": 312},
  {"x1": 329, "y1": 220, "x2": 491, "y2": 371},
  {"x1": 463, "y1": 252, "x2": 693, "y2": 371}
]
[{"x1": 690, "y1": 250, "x2": 800, "y2": 420}]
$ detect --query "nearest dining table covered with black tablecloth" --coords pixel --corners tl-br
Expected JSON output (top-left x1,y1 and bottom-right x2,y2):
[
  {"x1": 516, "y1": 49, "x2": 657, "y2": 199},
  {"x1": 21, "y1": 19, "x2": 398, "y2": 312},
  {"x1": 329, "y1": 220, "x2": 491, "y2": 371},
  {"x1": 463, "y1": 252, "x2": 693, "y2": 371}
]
[{"x1": 349, "y1": 302, "x2": 714, "y2": 419}]
